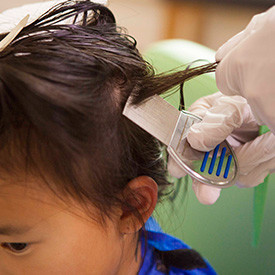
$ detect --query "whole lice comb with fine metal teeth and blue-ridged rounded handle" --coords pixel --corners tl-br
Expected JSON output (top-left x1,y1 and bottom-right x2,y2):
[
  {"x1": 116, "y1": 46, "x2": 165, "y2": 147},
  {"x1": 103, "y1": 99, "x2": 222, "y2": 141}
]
[{"x1": 123, "y1": 95, "x2": 238, "y2": 188}]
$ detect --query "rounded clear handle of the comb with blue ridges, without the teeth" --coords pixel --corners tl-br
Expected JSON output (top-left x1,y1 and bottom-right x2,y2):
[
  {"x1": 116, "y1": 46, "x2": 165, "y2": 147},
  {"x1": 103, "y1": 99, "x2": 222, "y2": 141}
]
[{"x1": 167, "y1": 111, "x2": 238, "y2": 188}]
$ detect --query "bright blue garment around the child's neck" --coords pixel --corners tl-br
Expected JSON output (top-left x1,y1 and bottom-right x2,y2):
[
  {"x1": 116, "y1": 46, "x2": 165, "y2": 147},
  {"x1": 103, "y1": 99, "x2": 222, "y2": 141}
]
[{"x1": 138, "y1": 217, "x2": 217, "y2": 275}]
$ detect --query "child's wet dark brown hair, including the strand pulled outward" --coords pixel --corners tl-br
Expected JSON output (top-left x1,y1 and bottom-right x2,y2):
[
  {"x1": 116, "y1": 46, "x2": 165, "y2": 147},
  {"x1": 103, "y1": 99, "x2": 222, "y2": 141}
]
[{"x1": 0, "y1": 1, "x2": 218, "y2": 272}]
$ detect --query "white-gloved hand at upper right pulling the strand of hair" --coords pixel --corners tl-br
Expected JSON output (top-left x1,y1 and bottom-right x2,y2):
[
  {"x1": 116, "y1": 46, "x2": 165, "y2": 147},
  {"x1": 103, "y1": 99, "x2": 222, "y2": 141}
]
[{"x1": 216, "y1": 6, "x2": 275, "y2": 134}]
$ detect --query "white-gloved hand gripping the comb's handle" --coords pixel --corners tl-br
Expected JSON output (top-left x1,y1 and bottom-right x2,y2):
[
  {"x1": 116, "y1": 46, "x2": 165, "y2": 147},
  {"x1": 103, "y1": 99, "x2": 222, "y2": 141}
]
[{"x1": 168, "y1": 92, "x2": 275, "y2": 204}]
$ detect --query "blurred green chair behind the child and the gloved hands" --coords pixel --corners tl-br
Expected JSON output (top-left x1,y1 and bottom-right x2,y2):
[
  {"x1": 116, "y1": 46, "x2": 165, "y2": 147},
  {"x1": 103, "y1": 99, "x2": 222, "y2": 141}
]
[{"x1": 144, "y1": 39, "x2": 275, "y2": 275}]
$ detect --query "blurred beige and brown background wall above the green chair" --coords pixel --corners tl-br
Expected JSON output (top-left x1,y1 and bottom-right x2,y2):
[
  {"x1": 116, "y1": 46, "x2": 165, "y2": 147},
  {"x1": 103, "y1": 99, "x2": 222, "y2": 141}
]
[{"x1": 0, "y1": 0, "x2": 275, "y2": 51}]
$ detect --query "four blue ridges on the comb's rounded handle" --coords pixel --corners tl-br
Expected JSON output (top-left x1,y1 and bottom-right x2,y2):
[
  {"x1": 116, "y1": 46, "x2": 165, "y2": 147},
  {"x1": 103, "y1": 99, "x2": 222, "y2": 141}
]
[{"x1": 200, "y1": 147, "x2": 232, "y2": 179}]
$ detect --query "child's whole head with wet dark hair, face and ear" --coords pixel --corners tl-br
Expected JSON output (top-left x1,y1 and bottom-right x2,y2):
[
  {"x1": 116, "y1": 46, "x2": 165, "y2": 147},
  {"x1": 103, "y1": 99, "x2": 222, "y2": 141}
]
[{"x1": 0, "y1": 1, "x2": 217, "y2": 275}]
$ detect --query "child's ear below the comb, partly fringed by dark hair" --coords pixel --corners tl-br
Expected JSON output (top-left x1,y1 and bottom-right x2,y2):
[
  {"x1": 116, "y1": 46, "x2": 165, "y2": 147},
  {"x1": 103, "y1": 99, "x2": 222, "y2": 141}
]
[{"x1": 119, "y1": 176, "x2": 158, "y2": 234}]
